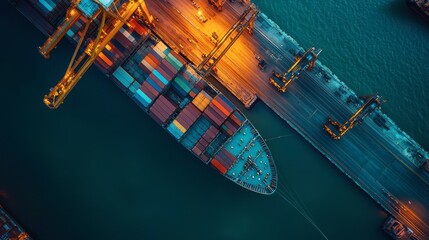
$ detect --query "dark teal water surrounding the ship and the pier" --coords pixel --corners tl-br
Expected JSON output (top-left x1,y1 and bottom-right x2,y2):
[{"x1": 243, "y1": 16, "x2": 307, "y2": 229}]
[{"x1": 0, "y1": 0, "x2": 429, "y2": 239}]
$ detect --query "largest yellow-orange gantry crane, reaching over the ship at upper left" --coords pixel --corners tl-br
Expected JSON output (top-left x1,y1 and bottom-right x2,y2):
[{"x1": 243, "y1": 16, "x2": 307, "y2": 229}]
[{"x1": 39, "y1": 0, "x2": 153, "y2": 109}]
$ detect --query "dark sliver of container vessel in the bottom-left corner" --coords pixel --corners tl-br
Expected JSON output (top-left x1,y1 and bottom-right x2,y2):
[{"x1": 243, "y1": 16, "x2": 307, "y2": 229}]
[{"x1": 0, "y1": 205, "x2": 32, "y2": 240}]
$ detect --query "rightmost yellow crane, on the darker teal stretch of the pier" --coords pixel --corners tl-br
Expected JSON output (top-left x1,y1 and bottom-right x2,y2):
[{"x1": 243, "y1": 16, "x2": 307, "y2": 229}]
[{"x1": 323, "y1": 94, "x2": 384, "y2": 140}]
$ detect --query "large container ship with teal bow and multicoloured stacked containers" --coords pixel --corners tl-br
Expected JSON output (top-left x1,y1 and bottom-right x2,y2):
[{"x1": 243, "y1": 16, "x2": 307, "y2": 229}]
[{"x1": 11, "y1": 0, "x2": 277, "y2": 195}]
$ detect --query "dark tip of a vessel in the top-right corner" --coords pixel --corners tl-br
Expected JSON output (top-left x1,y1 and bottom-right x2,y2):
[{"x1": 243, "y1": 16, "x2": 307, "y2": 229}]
[{"x1": 383, "y1": 0, "x2": 428, "y2": 27}]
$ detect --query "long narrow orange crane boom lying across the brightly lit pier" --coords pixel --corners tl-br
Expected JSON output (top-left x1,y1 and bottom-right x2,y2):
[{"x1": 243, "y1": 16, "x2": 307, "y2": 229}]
[{"x1": 197, "y1": 4, "x2": 259, "y2": 77}]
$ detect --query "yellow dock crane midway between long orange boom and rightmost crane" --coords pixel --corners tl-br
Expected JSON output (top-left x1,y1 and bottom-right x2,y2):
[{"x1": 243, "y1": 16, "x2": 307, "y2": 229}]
[{"x1": 269, "y1": 47, "x2": 322, "y2": 93}]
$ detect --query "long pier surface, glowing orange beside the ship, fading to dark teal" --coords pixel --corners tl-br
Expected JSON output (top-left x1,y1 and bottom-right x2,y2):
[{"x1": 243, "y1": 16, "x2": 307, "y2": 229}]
[{"x1": 147, "y1": 0, "x2": 429, "y2": 239}]
